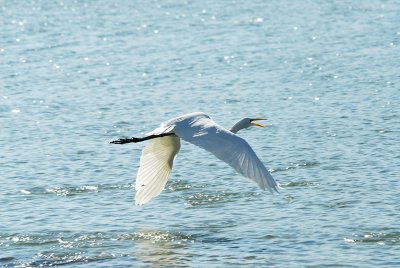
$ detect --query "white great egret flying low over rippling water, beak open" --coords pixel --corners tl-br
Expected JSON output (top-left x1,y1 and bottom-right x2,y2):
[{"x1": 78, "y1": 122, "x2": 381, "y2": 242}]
[{"x1": 111, "y1": 112, "x2": 278, "y2": 205}]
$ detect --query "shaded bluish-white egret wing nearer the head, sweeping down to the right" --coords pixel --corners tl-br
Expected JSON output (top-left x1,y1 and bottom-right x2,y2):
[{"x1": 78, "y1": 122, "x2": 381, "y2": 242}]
[{"x1": 174, "y1": 115, "x2": 278, "y2": 192}]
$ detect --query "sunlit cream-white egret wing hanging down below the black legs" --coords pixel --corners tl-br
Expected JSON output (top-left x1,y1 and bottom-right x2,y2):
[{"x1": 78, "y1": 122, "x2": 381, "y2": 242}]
[{"x1": 135, "y1": 136, "x2": 181, "y2": 205}]
